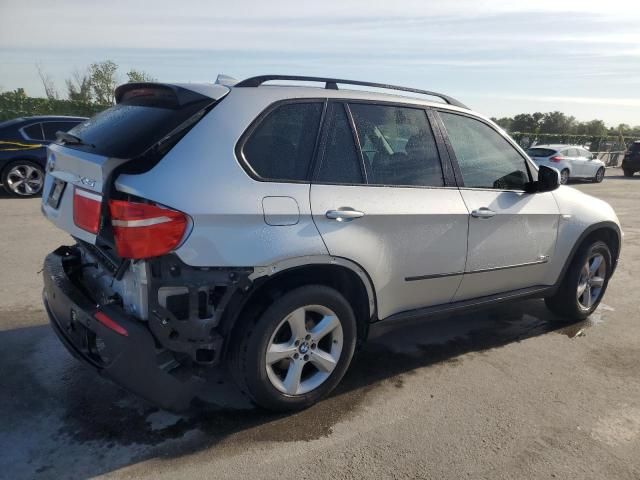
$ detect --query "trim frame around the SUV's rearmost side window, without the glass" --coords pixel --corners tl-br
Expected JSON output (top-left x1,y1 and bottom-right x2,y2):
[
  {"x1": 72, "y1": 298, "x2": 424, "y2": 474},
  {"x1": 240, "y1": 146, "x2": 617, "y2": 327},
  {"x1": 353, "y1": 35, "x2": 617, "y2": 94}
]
[{"x1": 234, "y1": 97, "x2": 327, "y2": 184}]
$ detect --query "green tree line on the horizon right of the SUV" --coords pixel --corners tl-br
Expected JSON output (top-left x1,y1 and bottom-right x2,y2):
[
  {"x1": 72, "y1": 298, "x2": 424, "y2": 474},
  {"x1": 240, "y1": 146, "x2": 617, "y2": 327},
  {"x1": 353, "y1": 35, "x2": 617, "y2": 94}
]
[{"x1": 492, "y1": 111, "x2": 640, "y2": 137}]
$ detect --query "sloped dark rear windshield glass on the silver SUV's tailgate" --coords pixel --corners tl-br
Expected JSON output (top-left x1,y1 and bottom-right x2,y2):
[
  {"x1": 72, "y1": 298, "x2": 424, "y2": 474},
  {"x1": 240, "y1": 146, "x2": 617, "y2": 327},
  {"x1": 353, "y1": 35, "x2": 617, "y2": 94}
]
[{"x1": 65, "y1": 87, "x2": 214, "y2": 158}]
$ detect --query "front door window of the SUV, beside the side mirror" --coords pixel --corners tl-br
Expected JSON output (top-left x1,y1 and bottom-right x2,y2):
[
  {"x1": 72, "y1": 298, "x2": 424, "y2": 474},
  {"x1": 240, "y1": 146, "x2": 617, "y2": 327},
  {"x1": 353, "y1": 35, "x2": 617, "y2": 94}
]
[{"x1": 440, "y1": 113, "x2": 529, "y2": 190}]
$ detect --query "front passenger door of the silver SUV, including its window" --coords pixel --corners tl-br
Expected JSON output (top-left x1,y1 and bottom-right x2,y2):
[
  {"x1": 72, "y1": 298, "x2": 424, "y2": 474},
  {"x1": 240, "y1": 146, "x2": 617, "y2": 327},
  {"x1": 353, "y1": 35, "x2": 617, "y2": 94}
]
[{"x1": 440, "y1": 111, "x2": 559, "y2": 300}]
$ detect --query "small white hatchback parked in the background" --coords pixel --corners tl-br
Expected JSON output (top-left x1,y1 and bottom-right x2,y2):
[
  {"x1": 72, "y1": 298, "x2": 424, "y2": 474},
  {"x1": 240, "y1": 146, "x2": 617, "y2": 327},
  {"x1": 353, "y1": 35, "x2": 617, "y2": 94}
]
[{"x1": 527, "y1": 145, "x2": 605, "y2": 184}]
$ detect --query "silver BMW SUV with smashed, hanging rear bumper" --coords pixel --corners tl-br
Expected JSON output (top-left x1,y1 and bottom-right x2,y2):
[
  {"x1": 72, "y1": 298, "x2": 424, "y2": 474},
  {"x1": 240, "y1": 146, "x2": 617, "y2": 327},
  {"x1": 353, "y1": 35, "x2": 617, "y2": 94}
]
[{"x1": 42, "y1": 76, "x2": 622, "y2": 410}]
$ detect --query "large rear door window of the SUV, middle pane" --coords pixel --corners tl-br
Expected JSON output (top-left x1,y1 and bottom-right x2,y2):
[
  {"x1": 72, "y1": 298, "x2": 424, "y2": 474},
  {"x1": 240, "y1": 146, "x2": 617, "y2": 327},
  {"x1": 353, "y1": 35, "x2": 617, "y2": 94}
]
[{"x1": 350, "y1": 104, "x2": 444, "y2": 187}]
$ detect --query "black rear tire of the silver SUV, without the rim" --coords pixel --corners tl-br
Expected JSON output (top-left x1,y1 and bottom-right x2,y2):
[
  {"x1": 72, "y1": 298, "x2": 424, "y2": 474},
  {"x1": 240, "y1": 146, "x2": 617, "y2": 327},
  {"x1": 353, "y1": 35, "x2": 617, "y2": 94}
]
[{"x1": 231, "y1": 285, "x2": 357, "y2": 411}]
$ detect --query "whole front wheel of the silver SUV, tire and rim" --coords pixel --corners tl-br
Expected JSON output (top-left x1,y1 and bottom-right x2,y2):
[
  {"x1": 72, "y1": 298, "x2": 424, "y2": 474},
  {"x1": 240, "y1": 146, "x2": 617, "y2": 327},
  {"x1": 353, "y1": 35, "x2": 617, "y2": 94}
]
[{"x1": 545, "y1": 240, "x2": 612, "y2": 320}]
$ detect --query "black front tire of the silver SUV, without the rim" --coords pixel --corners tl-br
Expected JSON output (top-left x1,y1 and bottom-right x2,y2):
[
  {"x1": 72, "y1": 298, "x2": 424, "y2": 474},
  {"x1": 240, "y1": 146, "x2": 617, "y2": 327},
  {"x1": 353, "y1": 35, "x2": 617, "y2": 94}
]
[{"x1": 544, "y1": 240, "x2": 612, "y2": 320}]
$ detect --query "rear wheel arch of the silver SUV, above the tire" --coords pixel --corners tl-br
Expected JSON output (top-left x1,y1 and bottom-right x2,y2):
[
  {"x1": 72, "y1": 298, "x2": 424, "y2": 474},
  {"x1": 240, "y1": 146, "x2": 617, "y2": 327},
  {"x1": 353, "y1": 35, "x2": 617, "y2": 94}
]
[{"x1": 220, "y1": 256, "x2": 376, "y2": 357}]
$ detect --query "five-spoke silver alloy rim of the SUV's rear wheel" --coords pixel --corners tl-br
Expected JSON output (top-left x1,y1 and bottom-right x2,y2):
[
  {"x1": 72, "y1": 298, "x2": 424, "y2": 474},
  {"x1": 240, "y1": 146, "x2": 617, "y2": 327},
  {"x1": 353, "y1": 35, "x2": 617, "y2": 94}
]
[{"x1": 265, "y1": 305, "x2": 344, "y2": 395}]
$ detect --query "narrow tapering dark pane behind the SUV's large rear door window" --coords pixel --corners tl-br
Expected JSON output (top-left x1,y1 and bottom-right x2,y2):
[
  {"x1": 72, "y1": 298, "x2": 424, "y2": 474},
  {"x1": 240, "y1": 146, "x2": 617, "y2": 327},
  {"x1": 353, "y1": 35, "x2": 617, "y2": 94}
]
[{"x1": 318, "y1": 104, "x2": 363, "y2": 184}]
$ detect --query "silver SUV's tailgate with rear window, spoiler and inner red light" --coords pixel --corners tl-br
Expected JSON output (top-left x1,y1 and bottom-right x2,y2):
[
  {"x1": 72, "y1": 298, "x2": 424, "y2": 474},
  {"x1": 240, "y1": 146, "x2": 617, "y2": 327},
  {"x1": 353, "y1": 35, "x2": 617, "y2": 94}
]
[{"x1": 42, "y1": 83, "x2": 229, "y2": 244}]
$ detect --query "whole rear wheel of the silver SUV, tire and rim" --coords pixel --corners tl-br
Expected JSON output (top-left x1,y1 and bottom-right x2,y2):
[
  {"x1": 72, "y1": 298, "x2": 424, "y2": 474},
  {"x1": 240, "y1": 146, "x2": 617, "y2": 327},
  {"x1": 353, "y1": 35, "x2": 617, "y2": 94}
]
[{"x1": 232, "y1": 285, "x2": 357, "y2": 411}]
